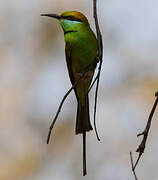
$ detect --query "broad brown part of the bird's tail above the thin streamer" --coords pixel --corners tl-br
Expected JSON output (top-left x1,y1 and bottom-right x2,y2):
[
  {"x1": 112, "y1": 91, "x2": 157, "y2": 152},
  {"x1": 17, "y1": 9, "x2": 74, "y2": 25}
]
[{"x1": 76, "y1": 95, "x2": 93, "y2": 134}]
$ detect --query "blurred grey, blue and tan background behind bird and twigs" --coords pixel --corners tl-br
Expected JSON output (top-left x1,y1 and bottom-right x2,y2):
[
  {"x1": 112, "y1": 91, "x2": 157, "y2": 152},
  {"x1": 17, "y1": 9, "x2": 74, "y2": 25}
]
[{"x1": 0, "y1": 0, "x2": 158, "y2": 180}]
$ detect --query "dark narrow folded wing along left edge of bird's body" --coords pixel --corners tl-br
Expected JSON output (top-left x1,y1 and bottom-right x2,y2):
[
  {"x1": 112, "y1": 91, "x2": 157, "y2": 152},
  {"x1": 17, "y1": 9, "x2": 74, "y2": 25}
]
[{"x1": 65, "y1": 43, "x2": 75, "y2": 85}]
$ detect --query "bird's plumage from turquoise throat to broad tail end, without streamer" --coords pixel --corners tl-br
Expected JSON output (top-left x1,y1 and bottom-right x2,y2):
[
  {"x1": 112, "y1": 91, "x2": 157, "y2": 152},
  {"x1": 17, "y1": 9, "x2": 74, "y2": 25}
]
[{"x1": 60, "y1": 16, "x2": 97, "y2": 134}]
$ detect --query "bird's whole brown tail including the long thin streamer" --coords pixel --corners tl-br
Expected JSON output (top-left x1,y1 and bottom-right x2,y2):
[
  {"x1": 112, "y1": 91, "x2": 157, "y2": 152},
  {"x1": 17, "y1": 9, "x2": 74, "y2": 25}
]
[{"x1": 76, "y1": 95, "x2": 93, "y2": 176}]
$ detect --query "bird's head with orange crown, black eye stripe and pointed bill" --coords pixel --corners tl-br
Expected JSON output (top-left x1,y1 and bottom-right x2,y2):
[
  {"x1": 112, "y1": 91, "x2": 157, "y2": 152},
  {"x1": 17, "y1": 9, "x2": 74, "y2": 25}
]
[{"x1": 41, "y1": 11, "x2": 89, "y2": 32}]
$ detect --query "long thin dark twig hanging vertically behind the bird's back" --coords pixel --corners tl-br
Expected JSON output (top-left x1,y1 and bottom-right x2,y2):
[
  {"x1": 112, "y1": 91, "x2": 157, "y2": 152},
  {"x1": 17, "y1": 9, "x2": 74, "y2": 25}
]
[{"x1": 90, "y1": 0, "x2": 103, "y2": 141}]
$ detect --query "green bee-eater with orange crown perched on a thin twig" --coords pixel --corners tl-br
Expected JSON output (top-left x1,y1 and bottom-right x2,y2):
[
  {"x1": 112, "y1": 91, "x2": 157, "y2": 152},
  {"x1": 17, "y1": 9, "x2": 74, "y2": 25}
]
[{"x1": 41, "y1": 11, "x2": 98, "y2": 176}]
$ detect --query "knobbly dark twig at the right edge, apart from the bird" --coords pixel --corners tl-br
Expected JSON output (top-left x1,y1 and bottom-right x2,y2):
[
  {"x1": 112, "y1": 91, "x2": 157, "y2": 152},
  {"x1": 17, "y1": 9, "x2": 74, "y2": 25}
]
[{"x1": 134, "y1": 92, "x2": 158, "y2": 169}]
